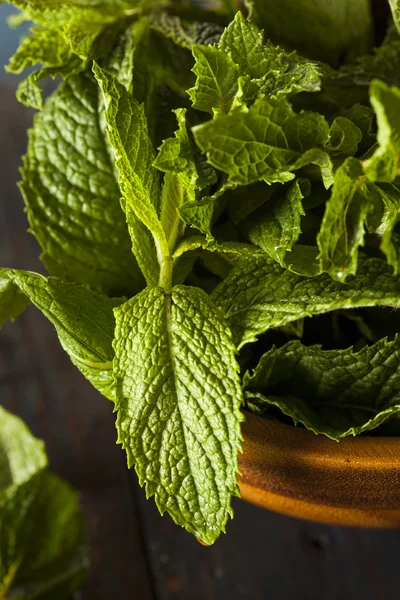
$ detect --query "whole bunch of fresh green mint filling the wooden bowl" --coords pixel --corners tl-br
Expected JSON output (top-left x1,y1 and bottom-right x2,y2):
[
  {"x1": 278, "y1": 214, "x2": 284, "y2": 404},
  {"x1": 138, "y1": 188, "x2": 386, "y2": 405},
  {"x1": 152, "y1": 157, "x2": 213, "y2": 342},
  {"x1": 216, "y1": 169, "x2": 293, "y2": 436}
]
[{"x1": 0, "y1": 0, "x2": 400, "y2": 544}]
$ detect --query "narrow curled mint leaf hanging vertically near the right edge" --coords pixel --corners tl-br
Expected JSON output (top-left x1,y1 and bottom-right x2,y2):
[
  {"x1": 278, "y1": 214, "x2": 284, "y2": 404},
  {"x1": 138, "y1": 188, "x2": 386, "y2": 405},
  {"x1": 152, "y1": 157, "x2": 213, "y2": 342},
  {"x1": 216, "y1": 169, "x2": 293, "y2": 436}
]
[{"x1": 317, "y1": 158, "x2": 381, "y2": 281}]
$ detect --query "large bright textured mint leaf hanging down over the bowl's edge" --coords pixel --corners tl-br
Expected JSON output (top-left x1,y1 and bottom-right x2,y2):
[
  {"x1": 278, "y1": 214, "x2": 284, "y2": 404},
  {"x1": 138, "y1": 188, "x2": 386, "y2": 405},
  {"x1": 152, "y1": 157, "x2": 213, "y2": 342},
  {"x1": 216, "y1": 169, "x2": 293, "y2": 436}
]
[{"x1": 114, "y1": 286, "x2": 241, "y2": 544}]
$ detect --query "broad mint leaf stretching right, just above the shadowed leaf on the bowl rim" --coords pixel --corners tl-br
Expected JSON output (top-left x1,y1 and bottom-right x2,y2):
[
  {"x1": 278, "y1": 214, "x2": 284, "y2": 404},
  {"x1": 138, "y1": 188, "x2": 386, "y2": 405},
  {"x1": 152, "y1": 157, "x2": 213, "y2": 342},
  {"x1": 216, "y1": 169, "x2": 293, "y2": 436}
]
[{"x1": 211, "y1": 256, "x2": 400, "y2": 348}]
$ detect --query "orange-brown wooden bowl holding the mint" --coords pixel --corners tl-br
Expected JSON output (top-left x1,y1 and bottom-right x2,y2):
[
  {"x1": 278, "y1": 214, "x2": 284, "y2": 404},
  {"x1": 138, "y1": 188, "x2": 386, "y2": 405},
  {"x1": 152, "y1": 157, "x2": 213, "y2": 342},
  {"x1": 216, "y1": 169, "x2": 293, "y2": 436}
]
[{"x1": 239, "y1": 413, "x2": 400, "y2": 527}]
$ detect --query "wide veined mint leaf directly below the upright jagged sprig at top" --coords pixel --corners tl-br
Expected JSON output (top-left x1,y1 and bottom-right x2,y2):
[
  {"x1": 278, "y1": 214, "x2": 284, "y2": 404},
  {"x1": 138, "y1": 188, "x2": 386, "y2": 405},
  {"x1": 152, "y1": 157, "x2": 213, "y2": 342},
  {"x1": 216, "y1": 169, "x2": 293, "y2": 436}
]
[{"x1": 193, "y1": 98, "x2": 329, "y2": 185}]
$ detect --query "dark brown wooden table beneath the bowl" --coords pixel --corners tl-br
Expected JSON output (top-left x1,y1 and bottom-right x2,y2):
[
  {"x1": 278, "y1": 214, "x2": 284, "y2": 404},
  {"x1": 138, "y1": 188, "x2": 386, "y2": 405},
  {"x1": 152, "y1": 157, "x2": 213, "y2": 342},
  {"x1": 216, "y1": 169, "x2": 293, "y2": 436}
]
[{"x1": 0, "y1": 86, "x2": 400, "y2": 600}]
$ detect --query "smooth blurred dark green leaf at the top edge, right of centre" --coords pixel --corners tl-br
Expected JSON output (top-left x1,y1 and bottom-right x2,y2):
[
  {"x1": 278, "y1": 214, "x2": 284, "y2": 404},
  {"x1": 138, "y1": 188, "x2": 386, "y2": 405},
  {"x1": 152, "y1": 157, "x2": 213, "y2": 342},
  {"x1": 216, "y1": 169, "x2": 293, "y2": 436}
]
[{"x1": 245, "y1": 0, "x2": 372, "y2": 65}]
